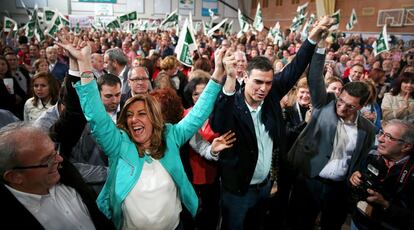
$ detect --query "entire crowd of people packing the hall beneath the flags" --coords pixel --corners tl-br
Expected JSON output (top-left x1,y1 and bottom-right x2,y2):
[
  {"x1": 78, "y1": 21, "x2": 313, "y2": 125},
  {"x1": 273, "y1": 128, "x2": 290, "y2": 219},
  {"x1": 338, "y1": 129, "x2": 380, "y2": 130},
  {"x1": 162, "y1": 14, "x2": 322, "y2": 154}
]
[{"x1": 0, "y1": 11, "x2": 414, "y2": 230}]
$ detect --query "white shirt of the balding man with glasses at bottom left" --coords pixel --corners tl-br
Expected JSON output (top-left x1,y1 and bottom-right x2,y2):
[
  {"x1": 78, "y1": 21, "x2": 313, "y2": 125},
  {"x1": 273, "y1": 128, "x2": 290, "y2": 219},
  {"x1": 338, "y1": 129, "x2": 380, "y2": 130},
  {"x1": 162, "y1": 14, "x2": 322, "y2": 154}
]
[{"x1": 6, "y1": 184, "x2": 95, "y2": 230}]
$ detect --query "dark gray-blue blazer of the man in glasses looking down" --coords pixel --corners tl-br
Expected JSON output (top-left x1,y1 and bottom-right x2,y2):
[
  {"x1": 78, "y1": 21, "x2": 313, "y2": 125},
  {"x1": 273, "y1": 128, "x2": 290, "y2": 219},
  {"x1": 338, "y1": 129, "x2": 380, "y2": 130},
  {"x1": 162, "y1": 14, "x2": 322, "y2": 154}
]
[{"x1": 288, "y1": 53, "x2": 375, "y2": 178}]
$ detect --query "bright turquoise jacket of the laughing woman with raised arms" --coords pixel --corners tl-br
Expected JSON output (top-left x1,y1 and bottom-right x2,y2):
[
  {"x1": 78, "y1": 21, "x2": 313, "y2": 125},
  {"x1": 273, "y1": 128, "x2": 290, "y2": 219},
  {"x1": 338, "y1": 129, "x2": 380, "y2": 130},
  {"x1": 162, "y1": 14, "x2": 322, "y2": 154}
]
[{"x1": 75, "y1": 80, "x2": 221, "y2": 229}]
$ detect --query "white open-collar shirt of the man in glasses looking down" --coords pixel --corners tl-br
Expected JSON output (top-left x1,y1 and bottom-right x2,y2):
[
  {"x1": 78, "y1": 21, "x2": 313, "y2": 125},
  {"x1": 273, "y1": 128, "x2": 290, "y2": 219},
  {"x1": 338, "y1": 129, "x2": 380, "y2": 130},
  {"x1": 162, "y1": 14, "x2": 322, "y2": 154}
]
[{"x1": 319, "y1": 118, "x2": 358, "y2": 181}]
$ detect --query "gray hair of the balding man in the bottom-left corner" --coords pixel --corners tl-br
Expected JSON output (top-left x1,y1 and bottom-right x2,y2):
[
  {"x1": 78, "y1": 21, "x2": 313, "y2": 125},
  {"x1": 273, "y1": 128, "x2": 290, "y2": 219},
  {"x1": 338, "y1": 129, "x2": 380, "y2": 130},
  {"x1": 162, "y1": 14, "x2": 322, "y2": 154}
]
[{"x1": 0, "y1": 121, "x2": 47, "y2": 176}]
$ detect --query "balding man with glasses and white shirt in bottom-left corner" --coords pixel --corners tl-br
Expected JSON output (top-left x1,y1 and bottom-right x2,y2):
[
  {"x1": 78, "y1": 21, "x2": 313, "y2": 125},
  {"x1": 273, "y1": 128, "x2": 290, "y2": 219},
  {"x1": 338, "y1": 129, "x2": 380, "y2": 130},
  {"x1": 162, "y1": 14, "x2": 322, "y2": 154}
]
[{"x1": 0, "y1": 123, "x2": 113, "y2": 230}]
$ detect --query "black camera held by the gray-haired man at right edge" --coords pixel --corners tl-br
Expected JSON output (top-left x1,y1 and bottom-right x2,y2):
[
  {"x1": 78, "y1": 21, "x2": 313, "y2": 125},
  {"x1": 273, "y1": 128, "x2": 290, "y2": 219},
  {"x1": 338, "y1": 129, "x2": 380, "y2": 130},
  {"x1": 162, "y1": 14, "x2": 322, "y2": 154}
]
[{"x1": 351, "y1": 163, "x2": 386, "y2": 201}]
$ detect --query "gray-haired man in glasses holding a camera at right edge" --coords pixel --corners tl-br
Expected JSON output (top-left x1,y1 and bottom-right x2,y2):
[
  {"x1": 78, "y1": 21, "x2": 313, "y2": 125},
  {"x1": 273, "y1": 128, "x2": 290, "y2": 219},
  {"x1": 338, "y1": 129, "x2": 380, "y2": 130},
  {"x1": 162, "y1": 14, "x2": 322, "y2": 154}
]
[{"x1": 349, "y1": 120, "x2": 414, "y2": 230}]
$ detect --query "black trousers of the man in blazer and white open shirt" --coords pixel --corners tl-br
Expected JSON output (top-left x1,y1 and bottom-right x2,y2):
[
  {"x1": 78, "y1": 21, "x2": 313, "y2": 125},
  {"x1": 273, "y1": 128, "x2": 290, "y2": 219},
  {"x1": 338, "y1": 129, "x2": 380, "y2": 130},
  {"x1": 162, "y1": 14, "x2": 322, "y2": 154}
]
[{"x1": 289, "y1": 176, "x2": 348, "y2": 230}]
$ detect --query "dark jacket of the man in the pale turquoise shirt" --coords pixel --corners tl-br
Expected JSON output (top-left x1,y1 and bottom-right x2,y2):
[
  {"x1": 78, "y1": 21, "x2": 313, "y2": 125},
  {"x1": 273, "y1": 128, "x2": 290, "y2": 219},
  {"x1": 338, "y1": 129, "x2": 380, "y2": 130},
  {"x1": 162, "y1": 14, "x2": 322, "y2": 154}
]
[{"x1": 210, "y1": 40, "x2": 315, "y2": 195}]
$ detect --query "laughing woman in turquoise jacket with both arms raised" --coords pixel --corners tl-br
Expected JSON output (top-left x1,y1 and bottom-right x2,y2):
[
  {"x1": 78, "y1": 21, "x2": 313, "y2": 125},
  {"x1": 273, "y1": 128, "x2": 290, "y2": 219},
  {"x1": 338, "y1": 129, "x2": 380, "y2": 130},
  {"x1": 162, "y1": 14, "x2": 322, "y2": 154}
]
[{"x1": 59, "y1": 32, "x2": 225, "y2": 229}]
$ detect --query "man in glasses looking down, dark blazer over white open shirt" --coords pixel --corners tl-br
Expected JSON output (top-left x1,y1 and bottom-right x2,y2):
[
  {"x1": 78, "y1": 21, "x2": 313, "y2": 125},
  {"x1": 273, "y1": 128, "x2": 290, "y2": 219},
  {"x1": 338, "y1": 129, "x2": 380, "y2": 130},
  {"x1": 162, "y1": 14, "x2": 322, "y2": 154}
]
[{"x1": 288, "y1": 42, "x2": 375, "y2": 230}]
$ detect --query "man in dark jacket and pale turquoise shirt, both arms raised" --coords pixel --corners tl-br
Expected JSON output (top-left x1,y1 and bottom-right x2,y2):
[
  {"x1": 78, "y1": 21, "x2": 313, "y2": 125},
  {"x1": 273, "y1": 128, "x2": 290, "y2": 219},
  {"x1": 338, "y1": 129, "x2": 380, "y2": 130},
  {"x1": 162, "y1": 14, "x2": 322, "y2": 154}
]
[{"x1": 210, "y1": 17, "x2": 332, "y2": 229}]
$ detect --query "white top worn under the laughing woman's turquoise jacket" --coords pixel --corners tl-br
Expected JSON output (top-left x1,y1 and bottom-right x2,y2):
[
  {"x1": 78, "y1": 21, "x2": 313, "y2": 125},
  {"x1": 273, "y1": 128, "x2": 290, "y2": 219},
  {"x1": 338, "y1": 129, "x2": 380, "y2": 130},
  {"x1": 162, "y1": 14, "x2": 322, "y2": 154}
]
[{"x1": 122, "y1": 156, "x2": 181, "y2": 230}]
